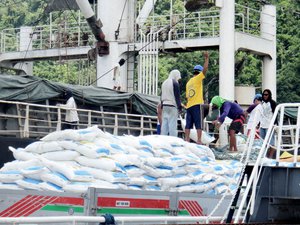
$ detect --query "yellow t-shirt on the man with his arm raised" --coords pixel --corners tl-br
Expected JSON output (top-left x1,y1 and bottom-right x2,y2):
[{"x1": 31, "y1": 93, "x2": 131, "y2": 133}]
[{"x1": 186, "y1": 72, "x2": 205, "y2": 108}]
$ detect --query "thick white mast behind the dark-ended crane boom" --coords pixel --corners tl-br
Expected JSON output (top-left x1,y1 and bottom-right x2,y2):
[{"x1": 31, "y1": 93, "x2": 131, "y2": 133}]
[{"x1": 97, "y1": 0, "x2": 129, "y2": 91}]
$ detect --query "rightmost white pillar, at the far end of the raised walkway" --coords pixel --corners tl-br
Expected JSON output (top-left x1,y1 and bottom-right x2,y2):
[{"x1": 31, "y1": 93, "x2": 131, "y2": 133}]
[{"x1": 261, "y1": 5, "x2": 277, "y2": 100}]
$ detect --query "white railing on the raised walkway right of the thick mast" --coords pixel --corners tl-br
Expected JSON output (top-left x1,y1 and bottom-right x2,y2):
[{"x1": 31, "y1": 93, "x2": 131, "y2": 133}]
[{"x1": 136, "y1": 4, "x2": 262, "y2": 41}]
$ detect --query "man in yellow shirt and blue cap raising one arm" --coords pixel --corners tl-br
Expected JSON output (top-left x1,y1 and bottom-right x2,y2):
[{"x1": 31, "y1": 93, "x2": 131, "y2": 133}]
[{"x1": 185, "y1": 52, "x2": 209, "y2": 144}]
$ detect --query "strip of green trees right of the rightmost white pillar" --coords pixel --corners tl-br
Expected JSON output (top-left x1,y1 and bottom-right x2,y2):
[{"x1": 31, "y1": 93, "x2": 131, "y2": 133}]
[{"x1": 277, "y1": 0, "x2": 300, "y2": 102}]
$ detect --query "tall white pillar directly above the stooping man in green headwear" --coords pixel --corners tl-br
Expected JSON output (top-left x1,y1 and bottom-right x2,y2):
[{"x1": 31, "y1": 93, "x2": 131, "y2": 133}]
[{"x1": 219, "y1": 0, "x2": 235, "y2": 100}]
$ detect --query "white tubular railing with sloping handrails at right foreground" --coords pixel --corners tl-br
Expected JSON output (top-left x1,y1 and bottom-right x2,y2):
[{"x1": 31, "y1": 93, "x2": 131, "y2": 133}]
[{"x1": 234, "y1": 103, "x2": 300, "y2": 223}]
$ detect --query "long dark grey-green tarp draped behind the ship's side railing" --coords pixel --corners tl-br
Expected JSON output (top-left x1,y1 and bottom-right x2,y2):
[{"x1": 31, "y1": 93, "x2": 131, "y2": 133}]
[{"x1": 0, "y1": 75, "x2": 159, "y2": 116}]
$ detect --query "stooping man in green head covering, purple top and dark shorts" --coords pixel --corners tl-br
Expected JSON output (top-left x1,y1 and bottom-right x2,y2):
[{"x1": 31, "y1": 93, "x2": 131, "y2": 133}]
[{"x1": 211, "y1": 96, "x2": 245, "y2": 152}]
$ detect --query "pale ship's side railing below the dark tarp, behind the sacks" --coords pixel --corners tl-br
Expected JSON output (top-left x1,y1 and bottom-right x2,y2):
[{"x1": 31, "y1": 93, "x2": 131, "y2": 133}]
[{"x1": 0, "y1": 100, "x2": 157, "y2": 138}]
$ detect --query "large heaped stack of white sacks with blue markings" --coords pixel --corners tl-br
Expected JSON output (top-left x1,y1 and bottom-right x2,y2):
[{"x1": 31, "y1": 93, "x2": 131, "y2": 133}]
[{"x1": 0, "y1": 127, "x2": 242, "y2": 194}]
